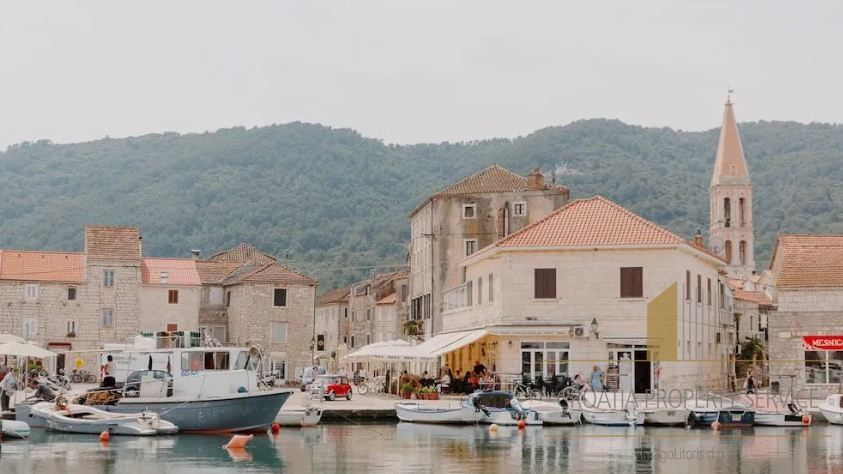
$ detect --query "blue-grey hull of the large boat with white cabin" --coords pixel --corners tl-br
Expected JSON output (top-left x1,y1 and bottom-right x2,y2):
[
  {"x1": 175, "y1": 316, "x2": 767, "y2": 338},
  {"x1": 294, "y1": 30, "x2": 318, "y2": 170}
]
[{"x1": 103, "y1": 390, "x2": 292, "y2": 433}]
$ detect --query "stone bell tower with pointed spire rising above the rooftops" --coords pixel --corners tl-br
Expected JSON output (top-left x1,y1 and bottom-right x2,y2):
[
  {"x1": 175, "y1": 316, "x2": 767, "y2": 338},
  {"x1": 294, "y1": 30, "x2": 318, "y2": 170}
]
[{"x1": 709, "y1": 89, "x2": 755, "y2": 278}]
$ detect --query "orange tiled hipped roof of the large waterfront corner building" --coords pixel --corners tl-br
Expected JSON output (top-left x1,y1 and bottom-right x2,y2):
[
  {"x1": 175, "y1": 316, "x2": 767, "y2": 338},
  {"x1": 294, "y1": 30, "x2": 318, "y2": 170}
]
[{"x1": 493, "y1": 196, "x2": 684, "y2": 248}]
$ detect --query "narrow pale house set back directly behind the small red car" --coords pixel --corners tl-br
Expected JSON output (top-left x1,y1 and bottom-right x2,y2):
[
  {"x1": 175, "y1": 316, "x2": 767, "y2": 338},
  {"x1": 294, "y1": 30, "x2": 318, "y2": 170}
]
[{"x1": 314, "y1": 287, "x2": 349, "y2": 372}]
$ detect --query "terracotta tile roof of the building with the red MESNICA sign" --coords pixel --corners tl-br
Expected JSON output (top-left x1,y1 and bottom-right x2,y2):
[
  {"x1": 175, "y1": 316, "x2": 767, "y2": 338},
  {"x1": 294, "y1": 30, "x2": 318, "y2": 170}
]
[{"x1": 772, "y1": 235, "x2": 843, "y2": 288}]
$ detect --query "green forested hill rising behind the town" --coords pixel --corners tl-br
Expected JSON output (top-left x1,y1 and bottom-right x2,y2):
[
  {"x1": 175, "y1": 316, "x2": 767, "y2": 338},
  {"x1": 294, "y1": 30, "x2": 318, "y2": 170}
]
[{"x1": 0, "y1": 120, "x2": 843, "y2": 290}]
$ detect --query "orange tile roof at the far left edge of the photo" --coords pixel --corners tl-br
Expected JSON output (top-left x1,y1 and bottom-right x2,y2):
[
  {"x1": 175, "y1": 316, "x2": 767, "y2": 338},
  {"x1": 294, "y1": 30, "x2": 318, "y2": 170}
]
[{"x1": 0, "y1": 250, "x2": 85, "y2": 284}]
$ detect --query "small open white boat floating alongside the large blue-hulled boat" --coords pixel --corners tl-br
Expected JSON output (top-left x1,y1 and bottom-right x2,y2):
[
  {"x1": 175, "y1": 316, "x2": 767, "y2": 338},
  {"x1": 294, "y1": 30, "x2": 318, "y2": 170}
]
[{"x1": 32, "y1": 399, "x2": 178, "y2": 436}]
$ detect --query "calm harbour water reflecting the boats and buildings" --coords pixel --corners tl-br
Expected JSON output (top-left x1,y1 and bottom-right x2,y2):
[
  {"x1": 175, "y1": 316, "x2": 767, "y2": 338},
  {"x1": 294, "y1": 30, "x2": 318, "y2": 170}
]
[{"x1": 0, "y1": 423, "x2": 843, "y2": 474}]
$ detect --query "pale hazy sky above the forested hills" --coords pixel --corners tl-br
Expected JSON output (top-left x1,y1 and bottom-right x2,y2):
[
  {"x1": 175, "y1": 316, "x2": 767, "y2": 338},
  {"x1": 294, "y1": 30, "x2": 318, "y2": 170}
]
[{"x1": 0, "y1": 0, "x2": 843, "y2": 148}]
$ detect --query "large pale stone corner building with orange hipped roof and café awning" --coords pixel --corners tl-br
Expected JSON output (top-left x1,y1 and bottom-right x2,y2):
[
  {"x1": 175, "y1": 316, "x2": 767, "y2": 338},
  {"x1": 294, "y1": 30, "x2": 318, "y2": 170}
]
[{"x1": 438, "y1": 196, "x2": 734, "y2": 393}]
